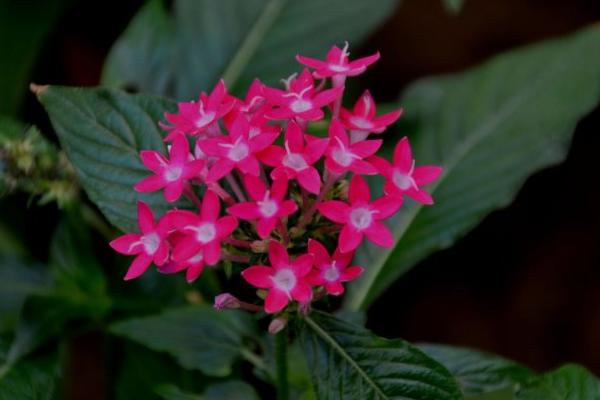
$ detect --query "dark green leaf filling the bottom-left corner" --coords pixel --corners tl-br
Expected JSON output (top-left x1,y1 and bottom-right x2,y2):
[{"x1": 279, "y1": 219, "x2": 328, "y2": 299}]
[{"x1": 0, "y1": 358, "x2": 58, "y2": 400}]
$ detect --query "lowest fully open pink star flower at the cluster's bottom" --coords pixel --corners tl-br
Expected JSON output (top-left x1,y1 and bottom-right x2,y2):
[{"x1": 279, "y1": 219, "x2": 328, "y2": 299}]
[{"x1": 242, "y1": 240, "x2": 314, "y2": 314}]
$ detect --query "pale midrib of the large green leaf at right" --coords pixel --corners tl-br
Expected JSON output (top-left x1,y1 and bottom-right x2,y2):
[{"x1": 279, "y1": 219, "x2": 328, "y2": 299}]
[{"x1": 347, "y1": 37, "x2": 566, "y2": 311}]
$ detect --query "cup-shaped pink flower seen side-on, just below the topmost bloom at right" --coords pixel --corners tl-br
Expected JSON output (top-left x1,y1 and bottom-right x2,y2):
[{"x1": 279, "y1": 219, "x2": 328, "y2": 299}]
[{"x1": 340, "y1": 90, "x2": 402, "y2": 133}]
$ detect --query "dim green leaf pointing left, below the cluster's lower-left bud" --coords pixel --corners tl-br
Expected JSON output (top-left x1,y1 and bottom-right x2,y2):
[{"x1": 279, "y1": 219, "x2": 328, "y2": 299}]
[{"x1": 111, "y1": 305, "x2": 253, "y2": 376}]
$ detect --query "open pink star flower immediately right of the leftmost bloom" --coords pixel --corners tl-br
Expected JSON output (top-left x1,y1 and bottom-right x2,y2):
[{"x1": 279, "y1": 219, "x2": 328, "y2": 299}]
[{"x1": 165, "y1": 190, "x2": 237, "y2": 265}]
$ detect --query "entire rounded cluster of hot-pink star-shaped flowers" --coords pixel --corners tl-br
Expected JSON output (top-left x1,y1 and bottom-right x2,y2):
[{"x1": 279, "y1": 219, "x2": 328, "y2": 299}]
[{"x1": 111, "y1": 44, "x2": 441, "y2": 313}]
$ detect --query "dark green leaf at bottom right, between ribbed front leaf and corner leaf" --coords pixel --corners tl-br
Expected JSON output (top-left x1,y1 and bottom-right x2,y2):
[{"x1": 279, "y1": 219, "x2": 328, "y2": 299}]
[{"x1": 417, "y1": 344, "x2": 534, "y2": 397}]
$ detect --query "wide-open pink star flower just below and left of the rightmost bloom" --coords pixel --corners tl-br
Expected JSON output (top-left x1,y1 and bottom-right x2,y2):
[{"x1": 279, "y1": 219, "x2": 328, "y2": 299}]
[{"x1": 318, "y1": 175, "x2": 402, "y2": 253}]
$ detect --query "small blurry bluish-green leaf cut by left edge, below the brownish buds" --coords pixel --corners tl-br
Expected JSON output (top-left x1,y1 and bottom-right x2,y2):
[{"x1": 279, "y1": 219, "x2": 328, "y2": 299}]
[{"x1": 0, "y1": 257, "x2": 50, "y2": 333}]
